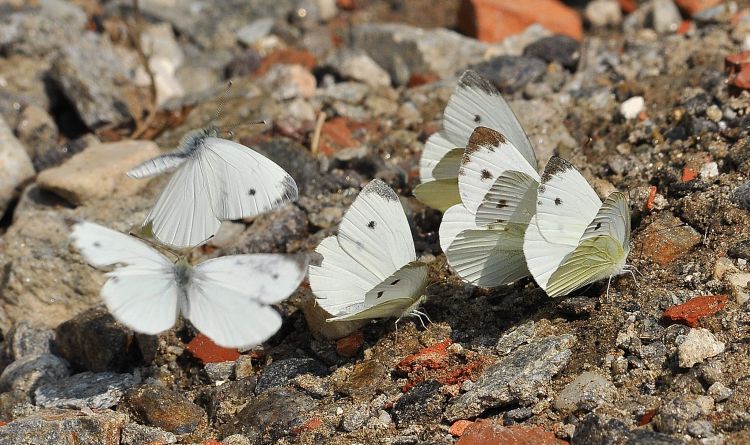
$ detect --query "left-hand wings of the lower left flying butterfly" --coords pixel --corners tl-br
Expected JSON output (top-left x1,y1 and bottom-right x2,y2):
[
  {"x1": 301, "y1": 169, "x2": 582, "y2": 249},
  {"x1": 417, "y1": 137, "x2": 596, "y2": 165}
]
[{"x1": 70, "y1": 222, "x2": 178, "y2": 334}]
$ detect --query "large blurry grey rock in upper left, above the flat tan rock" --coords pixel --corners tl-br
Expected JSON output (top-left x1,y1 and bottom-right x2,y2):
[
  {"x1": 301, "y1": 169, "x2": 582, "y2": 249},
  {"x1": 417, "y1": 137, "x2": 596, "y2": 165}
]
[{"x1": 50, "y1": 33, "x2": 131, "y2": 128}]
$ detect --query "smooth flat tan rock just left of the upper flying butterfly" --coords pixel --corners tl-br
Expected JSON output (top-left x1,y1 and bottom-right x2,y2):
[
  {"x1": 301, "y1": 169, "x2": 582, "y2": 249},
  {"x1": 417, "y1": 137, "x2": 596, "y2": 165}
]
[{"x1": 37, "y1": 141, "x2": 159, "y2": 205}]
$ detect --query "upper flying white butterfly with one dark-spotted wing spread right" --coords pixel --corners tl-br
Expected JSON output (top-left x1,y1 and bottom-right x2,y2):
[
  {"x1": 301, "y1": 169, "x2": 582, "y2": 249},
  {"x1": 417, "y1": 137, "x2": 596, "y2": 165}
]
[{"x1": 128, "y1": 126, "x2": 298, "y2": 248}]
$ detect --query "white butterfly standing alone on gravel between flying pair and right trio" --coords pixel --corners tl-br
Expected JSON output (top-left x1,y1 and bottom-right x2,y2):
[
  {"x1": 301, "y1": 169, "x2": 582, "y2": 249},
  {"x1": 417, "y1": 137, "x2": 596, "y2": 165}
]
[{"x1": 309, "y1": 179, "x2": 428, "y2": 321}]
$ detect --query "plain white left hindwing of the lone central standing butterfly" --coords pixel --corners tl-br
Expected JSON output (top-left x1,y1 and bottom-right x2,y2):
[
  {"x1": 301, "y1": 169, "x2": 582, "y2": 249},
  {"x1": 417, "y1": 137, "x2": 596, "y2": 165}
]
[{"x1": 309, "y1": 236, "x2": 380, "y2": 314}]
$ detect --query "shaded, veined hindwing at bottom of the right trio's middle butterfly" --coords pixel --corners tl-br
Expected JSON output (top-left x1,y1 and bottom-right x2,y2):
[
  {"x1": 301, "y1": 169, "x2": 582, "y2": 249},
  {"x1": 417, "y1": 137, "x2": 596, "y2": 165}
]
[{"x1": 445, "y1": 223, "x2": 529, "y2": 287}]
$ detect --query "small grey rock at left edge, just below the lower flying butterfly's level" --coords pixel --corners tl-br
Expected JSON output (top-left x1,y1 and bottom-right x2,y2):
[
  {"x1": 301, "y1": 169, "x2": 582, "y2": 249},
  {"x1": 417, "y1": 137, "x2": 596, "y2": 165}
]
[{"x1": 0, "y1": 354, "x2": 70, "y2": 393}]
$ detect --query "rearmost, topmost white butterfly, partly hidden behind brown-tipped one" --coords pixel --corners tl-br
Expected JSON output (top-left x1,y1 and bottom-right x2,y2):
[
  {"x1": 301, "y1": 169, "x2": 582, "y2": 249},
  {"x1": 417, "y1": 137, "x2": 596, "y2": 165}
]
[{"x1": 414, "y1": 70, "x2": 536, "y2": 211}]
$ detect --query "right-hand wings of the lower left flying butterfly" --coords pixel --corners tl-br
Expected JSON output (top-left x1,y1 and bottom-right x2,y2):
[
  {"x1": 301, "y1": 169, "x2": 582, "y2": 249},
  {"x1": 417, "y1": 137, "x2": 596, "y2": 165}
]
[{"x1": 188, "y1": 254, "x2": 306, "y2": 348}]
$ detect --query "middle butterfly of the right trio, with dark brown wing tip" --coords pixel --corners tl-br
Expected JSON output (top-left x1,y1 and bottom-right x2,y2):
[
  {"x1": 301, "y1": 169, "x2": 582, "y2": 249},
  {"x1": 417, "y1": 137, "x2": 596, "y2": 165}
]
[{"x1": 440, "y1": 127, "x2": 539, "y2": 287}]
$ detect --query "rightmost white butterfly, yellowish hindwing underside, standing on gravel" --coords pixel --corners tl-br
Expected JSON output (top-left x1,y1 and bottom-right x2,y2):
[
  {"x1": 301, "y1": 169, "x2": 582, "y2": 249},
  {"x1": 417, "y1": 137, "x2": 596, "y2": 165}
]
[{"x1": 523, "y1": 157, "x2": 630, "y2": 297}]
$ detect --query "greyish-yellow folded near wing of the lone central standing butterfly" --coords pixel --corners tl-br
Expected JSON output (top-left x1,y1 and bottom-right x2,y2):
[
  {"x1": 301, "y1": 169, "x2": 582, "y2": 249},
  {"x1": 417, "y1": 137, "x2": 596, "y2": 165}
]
[{"x1": 328, "y1": 261, "x2": 429, "y2": 321}]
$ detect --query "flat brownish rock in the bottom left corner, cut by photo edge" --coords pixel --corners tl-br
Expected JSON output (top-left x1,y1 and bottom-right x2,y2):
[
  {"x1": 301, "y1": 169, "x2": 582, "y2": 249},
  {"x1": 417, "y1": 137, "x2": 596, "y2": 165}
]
[{"x1": 0, "y1": 409, "x2": 128, "y2": 445}]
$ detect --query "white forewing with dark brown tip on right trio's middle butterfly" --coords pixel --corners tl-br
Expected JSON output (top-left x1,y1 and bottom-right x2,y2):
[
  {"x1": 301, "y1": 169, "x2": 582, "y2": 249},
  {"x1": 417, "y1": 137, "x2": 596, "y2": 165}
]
[{"x1": 458, "y1": 127, "x2": 539, "y2": 213}]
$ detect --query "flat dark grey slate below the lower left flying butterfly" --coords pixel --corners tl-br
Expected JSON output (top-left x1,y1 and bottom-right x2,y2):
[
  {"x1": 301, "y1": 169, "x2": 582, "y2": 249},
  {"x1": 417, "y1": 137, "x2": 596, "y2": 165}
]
[{"x1": 34, "y1": 372, "x2": 140, "y2": 409}]
